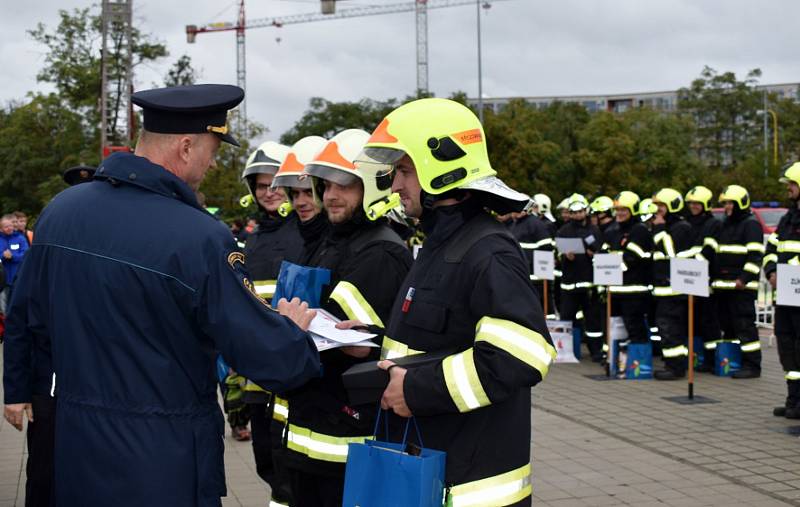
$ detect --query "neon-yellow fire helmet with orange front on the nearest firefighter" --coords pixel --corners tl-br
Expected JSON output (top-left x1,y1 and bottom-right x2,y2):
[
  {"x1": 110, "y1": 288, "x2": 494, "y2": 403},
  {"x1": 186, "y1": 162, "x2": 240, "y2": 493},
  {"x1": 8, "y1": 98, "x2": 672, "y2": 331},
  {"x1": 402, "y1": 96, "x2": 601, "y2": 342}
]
[{"x1": 364, "y1": 98, "x2": 528, "y2": 212}]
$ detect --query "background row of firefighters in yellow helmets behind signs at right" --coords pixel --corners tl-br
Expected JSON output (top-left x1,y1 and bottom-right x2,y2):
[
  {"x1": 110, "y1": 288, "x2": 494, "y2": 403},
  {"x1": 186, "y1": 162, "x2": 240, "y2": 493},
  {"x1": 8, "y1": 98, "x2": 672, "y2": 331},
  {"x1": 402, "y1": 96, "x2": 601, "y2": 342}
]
[{"x1": 501, "y1": 177, "x2": 800, "y2": 418}]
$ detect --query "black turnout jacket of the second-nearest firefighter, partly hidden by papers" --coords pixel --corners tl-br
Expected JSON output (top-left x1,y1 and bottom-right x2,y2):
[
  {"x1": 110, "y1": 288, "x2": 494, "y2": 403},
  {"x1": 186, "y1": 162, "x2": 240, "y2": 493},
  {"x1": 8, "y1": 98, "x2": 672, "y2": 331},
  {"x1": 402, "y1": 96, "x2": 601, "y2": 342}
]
[{"x1": 276, "y1": 217, "x2": 412, "y2": 477}]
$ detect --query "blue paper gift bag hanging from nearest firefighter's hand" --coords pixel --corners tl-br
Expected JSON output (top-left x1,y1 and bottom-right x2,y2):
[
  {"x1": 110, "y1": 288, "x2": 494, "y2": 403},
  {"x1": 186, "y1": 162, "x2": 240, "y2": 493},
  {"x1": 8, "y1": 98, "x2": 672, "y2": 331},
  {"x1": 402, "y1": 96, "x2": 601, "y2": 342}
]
[{"x1": 342, "y1": 414, "x2": 447, "y2": 507}]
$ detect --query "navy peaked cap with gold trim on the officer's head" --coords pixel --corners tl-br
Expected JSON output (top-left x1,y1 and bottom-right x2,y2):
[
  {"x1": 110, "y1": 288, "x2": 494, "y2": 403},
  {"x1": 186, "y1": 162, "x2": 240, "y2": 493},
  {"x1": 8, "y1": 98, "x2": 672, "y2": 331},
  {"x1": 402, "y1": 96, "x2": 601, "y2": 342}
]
[{"x1": 131, "y1": 84, "x2": 244, "y2": 146}]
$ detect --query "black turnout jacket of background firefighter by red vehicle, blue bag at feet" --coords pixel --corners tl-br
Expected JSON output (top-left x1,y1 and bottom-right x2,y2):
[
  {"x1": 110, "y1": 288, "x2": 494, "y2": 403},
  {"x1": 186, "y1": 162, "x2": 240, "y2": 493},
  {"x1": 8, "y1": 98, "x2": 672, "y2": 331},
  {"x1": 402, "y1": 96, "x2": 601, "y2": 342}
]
[{"x1": 711, "y1": 210, "x2": 766, "y2": 295}]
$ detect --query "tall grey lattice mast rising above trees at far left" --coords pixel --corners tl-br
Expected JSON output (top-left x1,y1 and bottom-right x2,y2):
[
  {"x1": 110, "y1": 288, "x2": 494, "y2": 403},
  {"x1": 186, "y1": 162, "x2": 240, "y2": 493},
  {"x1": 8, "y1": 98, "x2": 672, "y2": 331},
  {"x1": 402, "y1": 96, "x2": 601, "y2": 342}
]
[{"x1": 100, "y1": 0, "x2": 134, "y2": 159}]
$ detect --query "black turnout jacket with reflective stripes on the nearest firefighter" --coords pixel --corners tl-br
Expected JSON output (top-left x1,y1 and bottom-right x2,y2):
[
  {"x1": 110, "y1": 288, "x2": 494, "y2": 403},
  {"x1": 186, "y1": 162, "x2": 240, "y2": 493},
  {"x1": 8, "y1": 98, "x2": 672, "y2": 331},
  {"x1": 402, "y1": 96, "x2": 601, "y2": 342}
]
[{"x1": 381, "y1": 199, "x2": 556, "y2": 506}]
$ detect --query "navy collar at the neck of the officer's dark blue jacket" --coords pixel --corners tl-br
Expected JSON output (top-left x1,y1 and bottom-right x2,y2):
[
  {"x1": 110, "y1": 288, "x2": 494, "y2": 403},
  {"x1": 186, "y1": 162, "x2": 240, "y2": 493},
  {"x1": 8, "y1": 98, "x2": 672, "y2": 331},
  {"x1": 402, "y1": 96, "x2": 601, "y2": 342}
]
[{"x1": 94, "y1": 152, "x2": 205, "y2": 211}]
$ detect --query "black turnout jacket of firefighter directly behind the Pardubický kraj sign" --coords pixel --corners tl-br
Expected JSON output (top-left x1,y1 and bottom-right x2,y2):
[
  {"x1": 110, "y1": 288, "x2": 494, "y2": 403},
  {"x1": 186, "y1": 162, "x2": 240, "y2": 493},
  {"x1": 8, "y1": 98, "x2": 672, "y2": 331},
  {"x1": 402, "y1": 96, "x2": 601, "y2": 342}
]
[{"x1": 653, "y1": 213, "x2": 692, "y2": 297}]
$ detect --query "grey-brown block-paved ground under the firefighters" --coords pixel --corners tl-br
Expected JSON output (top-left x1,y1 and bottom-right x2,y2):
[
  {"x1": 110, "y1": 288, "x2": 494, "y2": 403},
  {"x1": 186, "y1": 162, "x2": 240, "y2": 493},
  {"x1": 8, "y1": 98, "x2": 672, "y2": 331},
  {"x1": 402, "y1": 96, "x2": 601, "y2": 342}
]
[{"x1": 0, "y1": 332, "x2": 800, "y2": 507}]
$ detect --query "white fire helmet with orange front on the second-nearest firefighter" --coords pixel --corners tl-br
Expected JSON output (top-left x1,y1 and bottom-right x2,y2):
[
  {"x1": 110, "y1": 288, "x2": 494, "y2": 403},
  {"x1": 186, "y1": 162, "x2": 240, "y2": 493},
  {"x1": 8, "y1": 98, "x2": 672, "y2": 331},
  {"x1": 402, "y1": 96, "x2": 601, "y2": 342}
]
[{"x1": 303, "y1": 129, "x2": 400, "y2": 220}]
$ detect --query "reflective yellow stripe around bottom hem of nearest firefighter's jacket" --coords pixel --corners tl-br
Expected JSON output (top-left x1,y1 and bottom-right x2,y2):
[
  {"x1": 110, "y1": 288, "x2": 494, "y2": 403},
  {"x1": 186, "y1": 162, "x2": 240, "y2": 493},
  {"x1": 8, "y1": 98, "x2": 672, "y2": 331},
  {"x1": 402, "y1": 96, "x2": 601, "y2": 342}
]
[{"x1": 450, "y1": 463, "x2": 533, "y2": 507}]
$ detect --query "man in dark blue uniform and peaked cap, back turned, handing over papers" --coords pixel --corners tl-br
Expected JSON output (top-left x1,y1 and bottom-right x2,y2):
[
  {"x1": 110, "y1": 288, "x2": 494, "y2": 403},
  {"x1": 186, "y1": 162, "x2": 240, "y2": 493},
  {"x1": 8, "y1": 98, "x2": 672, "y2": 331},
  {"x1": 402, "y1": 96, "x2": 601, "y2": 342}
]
[{"x1": 4, "y1": 85, "x2": 319, "y2": 507}]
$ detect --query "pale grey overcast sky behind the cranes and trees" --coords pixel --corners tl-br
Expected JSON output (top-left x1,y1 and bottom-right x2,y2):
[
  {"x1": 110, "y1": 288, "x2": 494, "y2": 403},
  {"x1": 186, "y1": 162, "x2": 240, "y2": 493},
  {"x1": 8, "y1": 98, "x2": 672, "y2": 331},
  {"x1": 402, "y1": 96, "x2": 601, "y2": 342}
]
[{"x1": 0, "y1": 0, "x2": 800, "y2": 137}]
